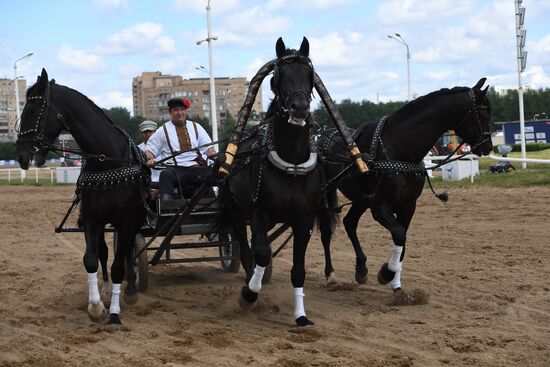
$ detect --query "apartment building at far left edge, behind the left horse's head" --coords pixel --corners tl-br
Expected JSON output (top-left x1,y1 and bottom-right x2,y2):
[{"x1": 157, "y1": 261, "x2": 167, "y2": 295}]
[{"x1": 0, "y1": 79, "x2": 27, "y2": 142}]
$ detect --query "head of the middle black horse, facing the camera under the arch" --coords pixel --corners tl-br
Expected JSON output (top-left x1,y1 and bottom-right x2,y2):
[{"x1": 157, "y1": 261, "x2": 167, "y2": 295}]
[{"x1": 271, "y1": 37, "x2": 314, "y2": 126}]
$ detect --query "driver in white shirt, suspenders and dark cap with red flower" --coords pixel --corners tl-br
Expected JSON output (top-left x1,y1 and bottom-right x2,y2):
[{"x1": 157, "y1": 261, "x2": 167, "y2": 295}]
[{"x1": 145, "y1": 98, "x2": 216, "y2": 200}]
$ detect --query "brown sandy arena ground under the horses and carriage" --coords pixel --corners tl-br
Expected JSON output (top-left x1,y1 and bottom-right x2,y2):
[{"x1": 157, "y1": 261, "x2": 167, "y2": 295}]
[{"x1": 0, "y1": 186, "x2": 550, "y2": 367}]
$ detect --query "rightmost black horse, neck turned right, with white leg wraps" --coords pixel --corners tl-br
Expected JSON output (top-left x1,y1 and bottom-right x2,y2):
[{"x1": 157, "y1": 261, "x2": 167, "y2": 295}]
[{"x1": 319, "y1": 78, "x2": 492, "y2": 298}]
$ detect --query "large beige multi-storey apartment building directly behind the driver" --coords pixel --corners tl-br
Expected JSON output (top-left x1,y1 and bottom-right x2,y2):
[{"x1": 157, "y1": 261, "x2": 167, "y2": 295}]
[{"x1": 132, "y1": 71, "x2": 263, "y2": 121}]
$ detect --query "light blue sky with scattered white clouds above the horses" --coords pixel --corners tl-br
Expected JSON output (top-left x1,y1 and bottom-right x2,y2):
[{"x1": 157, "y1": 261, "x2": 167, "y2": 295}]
[{"x1": 0, "y1": 0, "x2": 550, "y2": 111}]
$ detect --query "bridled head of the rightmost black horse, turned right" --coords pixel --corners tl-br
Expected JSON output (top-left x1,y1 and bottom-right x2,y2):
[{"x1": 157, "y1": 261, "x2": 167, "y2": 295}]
[{"x1": 455, "y1": 78, "x2": 493, "y2": 156}]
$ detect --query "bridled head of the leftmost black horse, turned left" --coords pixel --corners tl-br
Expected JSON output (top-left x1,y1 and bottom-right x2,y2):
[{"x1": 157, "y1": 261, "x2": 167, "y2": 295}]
[{"x1": 16, "y1": 69, "x2": 63, "y2": 169}]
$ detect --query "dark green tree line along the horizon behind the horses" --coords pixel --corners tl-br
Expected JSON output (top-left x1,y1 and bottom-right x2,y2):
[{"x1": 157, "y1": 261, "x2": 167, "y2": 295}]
[{"x1": 0, "y1": 88, "x2": 550, "y2": 160}]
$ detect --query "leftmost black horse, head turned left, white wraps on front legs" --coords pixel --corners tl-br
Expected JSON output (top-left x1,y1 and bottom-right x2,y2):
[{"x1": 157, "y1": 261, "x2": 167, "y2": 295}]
[{"x1": 17, "y1": 69, "x2": 149, "y2": 324}]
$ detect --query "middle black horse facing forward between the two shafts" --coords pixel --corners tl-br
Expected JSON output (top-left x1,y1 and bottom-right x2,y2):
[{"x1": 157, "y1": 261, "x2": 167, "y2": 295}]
[{"x1": 225, "y1": 37, "x2": 328, "y2": 326}]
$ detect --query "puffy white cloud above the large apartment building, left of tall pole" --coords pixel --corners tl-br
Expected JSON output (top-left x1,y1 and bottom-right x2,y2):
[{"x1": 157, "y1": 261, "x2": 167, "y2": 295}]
[{"x1": 99, "y1": 23, "x2": 176, "y2": 55}]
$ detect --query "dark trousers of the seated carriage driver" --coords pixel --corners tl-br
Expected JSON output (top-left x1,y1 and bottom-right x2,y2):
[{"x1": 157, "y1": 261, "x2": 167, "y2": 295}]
[{"x1": 159, "y1": 166, "x2": 210, "y2": 198}]
